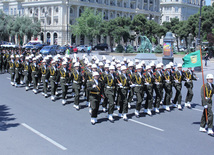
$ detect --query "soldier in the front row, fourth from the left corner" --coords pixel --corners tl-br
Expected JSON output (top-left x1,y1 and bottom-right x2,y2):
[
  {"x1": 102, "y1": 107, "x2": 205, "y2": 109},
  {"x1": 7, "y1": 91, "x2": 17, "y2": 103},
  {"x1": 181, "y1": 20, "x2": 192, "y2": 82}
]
[{"x1": 130, "y1": 65, "x2": 144, "y2": 118}]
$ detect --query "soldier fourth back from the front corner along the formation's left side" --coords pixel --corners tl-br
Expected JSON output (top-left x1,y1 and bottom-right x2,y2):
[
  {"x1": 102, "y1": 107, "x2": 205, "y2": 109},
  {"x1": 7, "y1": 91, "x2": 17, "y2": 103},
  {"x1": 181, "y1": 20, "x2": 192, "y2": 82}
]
[{"x1": 48, "y1": 60, "x2": 59, "y2": 101}]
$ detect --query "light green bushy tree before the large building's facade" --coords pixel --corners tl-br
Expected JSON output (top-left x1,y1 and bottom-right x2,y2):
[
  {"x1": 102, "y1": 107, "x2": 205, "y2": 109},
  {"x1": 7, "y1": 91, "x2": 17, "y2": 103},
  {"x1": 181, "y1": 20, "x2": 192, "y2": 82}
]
[{"x1": 70, "y1": 7, "x2": 102, "y2": 41}]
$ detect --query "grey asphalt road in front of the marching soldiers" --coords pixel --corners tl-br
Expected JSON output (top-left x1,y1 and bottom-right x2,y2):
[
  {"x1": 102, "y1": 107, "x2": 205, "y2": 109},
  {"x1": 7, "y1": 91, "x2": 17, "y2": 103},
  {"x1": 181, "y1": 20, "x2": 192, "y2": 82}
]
[{"x1": 0, "y1": 54, "x2": 214, "y2": 155}]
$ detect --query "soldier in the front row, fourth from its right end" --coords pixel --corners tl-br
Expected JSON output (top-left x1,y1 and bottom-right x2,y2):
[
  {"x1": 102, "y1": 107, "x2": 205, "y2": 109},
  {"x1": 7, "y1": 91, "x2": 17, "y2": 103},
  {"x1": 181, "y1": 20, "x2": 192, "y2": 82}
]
[{"x1": 153, "y1": 64, "x2": 164, "y2": 113}]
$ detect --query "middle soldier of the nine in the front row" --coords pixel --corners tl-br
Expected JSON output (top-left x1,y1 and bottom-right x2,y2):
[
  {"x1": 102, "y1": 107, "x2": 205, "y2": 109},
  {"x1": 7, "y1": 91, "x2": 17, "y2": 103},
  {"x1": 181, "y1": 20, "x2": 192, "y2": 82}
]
[{"x1": 144, "y1": 65, "x2": 154, "y2": 116}]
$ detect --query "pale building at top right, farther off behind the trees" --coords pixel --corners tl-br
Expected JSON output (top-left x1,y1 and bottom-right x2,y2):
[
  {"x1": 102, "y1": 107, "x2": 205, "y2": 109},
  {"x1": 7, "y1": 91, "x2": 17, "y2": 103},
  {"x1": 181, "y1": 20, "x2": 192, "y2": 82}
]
[{"x1": 160, "y1": 0, "x2": 205, "y2": 23}]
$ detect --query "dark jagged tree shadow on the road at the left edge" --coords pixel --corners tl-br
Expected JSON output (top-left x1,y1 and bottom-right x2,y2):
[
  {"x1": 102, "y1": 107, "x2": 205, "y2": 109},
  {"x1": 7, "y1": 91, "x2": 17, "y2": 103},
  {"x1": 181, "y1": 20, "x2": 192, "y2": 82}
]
[{"x1": 0, "y1": 105, "x2": 20, "y2": 131}]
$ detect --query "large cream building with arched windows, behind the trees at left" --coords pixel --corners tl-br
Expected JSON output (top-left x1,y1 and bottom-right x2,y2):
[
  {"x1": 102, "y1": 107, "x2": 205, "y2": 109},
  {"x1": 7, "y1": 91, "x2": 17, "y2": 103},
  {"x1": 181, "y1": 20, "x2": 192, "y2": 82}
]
[{"x1": 0, "y1": 0, "x2": 161, "y2": 45}]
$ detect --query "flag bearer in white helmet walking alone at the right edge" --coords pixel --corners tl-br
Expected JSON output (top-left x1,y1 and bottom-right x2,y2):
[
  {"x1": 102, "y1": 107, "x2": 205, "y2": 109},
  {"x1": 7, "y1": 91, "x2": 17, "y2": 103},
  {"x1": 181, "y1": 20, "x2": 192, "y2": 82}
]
[{"x1": 199, "y1": 74, "x2": 214, "y2": 137}]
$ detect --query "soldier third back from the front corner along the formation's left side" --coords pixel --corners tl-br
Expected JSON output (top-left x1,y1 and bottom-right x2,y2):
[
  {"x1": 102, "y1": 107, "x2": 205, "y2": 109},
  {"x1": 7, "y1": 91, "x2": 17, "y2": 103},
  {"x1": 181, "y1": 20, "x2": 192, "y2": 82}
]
[{"x1": 57, "y1": 61, "x2": 70, "y2": 105}]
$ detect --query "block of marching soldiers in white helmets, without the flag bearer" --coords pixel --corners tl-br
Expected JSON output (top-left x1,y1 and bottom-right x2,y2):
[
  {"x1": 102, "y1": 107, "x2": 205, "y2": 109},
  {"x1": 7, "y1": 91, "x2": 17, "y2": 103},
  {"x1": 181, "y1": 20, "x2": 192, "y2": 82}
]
[{"x1": 1, "y1": 49, "x2": 197, "y2": 124}]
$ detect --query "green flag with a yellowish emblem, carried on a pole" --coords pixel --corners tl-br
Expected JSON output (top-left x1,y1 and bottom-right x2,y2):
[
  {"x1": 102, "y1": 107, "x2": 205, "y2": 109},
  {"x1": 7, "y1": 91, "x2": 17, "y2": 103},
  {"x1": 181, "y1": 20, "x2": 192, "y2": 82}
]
[{"x1": 183, "y1": 50, "x2": 201, "y2": 68}]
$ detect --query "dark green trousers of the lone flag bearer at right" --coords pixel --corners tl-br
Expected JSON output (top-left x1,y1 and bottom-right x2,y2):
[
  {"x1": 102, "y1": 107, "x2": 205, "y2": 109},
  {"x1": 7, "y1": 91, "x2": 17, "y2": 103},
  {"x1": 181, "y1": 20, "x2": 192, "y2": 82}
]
[{"x1": 200, "y1": 106, "x2": 213, "y2": 128}]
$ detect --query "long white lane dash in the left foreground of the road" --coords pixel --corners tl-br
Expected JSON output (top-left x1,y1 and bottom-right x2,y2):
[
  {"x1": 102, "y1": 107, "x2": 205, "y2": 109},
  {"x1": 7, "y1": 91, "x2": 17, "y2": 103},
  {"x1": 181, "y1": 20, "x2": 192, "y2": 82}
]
[{"x1": 22, "y1": 123, "x2": 67, "y2": 150}]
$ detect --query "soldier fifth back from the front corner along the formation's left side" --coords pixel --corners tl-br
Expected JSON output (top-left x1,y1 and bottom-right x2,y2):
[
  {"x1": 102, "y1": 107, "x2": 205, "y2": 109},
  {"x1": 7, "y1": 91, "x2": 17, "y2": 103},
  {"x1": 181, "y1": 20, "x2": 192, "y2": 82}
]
[{"x1": 40, "y1": 60, "x2": 48, "y2": 98}]
